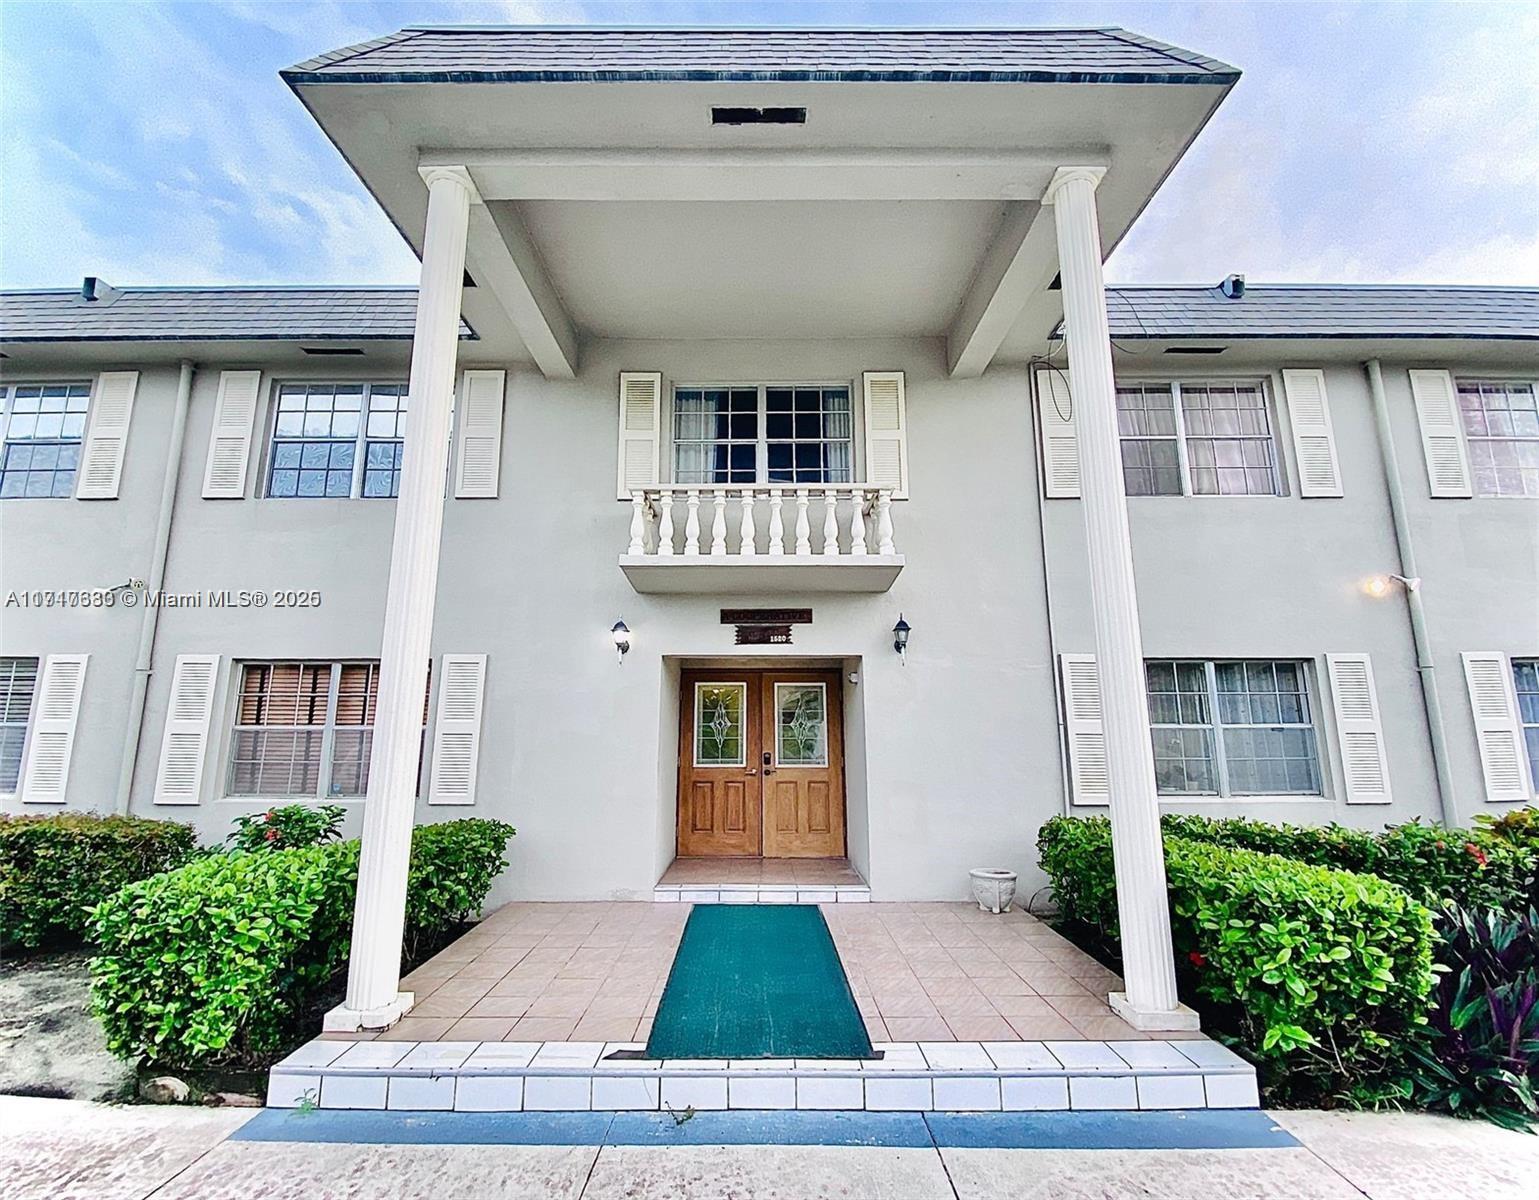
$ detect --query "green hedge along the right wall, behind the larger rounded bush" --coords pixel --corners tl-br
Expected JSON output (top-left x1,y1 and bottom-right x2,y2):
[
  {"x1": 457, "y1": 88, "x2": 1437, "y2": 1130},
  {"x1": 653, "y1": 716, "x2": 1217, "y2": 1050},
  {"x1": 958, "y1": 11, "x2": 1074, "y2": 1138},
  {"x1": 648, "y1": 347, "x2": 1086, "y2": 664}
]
[{"x1": 1162, "y1": 814, "x2": 1536, "y2": 912}]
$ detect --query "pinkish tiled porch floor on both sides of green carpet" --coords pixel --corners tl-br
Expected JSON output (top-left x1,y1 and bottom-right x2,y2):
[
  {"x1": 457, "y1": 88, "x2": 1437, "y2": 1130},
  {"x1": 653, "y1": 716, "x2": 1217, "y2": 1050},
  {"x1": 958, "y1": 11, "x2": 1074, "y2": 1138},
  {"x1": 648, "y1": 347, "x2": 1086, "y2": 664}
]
[{"x1": 337, "y1": 903, "x2": 1151, "y2": 1042}]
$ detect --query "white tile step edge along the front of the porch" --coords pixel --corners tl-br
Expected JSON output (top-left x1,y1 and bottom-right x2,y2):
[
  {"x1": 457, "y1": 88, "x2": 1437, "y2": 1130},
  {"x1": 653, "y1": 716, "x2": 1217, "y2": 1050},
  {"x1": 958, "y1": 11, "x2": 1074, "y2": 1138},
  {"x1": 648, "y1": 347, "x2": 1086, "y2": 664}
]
[{"x1": 268, "y1": 1038, "x2": 1260, "y2": 1112}]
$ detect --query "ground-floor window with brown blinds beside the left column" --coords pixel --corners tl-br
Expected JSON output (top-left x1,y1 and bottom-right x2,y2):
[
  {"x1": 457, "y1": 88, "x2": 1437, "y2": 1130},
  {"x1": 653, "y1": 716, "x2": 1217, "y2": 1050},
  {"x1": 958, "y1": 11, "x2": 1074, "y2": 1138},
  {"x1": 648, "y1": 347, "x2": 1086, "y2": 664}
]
[{"x1": 229, "y1": 662, "x2": 428, "y2": 798}]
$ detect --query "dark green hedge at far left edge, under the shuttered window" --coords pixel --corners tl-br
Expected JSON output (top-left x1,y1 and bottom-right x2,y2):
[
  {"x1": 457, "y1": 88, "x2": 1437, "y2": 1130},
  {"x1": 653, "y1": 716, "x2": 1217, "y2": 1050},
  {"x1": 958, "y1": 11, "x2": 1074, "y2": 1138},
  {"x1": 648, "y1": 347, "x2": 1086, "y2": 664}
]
[{"x1": 0, "y1": 812, "x2": 197, "y2": 949}]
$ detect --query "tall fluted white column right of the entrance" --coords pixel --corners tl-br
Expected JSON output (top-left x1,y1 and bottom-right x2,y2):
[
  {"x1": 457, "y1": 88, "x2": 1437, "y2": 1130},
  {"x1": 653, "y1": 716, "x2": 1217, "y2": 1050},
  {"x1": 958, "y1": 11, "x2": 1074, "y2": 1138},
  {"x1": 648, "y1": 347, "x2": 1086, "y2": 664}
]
[{"x1": 1043, "y1": 166, "x2": 1197, "y2": 1029}]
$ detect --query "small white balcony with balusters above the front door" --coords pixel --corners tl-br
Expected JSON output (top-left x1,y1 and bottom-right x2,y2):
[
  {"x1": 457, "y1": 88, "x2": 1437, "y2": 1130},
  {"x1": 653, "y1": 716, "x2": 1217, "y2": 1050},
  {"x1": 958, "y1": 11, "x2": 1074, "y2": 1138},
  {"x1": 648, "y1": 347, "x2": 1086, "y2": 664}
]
[{"x1": 620, "y1": 483, "x2": 903, "y2": 595}]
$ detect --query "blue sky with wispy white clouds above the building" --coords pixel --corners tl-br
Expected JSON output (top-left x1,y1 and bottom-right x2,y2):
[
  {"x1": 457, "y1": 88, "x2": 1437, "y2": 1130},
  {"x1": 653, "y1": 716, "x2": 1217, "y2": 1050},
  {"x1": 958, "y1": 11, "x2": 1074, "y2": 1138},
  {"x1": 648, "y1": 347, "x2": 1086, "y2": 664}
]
[{"x1": 0, "y1": 0, "x2": 1539, "y2": 288}]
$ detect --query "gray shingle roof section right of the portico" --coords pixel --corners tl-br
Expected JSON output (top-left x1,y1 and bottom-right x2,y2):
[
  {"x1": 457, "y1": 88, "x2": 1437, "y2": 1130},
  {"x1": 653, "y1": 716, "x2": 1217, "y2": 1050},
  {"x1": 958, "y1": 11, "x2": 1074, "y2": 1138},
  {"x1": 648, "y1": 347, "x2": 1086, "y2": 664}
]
[{"x1": 1107, "y1": 285, "x2": 1539, "y2": 340}]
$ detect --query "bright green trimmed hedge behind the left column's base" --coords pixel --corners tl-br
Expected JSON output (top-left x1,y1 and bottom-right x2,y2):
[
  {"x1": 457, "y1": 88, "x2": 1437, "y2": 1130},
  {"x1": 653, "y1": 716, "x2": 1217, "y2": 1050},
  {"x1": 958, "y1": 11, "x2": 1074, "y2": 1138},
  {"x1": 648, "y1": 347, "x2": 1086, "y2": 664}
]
[{"x1": 91, "y1": 820, "x2": 514, "y2": 1066}]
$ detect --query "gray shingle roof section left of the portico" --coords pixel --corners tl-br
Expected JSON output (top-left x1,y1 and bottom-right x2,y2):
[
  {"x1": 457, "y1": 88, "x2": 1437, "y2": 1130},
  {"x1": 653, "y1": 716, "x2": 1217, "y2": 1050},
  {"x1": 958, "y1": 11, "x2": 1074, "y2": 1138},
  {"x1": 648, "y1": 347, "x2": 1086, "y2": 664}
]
[{"x1": 0, "y1": 288, "x2": 476, "y2": 342}]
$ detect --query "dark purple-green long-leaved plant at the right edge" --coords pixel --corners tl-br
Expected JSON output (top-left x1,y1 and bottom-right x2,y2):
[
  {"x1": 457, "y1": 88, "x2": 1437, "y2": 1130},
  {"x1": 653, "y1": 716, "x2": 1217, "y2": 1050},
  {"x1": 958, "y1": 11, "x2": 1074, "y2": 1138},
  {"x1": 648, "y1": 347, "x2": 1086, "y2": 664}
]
[{"x1": 1414, "y1": 906, "x2": 1539, "y2": 1128}]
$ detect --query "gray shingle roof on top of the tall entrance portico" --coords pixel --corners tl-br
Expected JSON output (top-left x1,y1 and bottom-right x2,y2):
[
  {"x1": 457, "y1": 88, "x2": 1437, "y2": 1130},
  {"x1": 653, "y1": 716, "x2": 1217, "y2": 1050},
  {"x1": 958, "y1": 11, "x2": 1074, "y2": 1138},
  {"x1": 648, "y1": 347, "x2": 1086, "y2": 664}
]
[{"x1": 282, "y1": 26, "x2": 1239, "y2": 85}]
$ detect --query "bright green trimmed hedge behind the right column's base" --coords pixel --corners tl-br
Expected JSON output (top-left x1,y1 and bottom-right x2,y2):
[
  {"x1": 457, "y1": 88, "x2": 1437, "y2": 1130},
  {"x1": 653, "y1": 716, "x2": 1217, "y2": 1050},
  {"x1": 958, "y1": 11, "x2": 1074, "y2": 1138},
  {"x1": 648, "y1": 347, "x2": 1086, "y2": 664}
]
[{"x1": 1037, "y1": 817, "x2": 1433, "y2": 1100}]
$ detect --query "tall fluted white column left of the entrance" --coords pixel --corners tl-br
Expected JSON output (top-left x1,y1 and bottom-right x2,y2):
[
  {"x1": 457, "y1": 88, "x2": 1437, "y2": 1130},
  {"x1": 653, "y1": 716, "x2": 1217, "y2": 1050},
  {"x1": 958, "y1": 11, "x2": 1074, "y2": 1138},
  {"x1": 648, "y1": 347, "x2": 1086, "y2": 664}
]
[{"x1": 325, "y1": 166, "x2": 480, "y2": 1031}]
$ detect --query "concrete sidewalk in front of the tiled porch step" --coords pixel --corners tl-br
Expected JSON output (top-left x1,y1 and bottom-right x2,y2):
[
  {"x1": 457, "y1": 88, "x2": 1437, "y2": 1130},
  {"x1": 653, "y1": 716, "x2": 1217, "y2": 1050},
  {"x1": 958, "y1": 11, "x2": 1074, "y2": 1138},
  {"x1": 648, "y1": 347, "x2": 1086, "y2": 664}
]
[{"x1": 0, "y1": 1097, "x2": 1539, "y2": 1200}]
